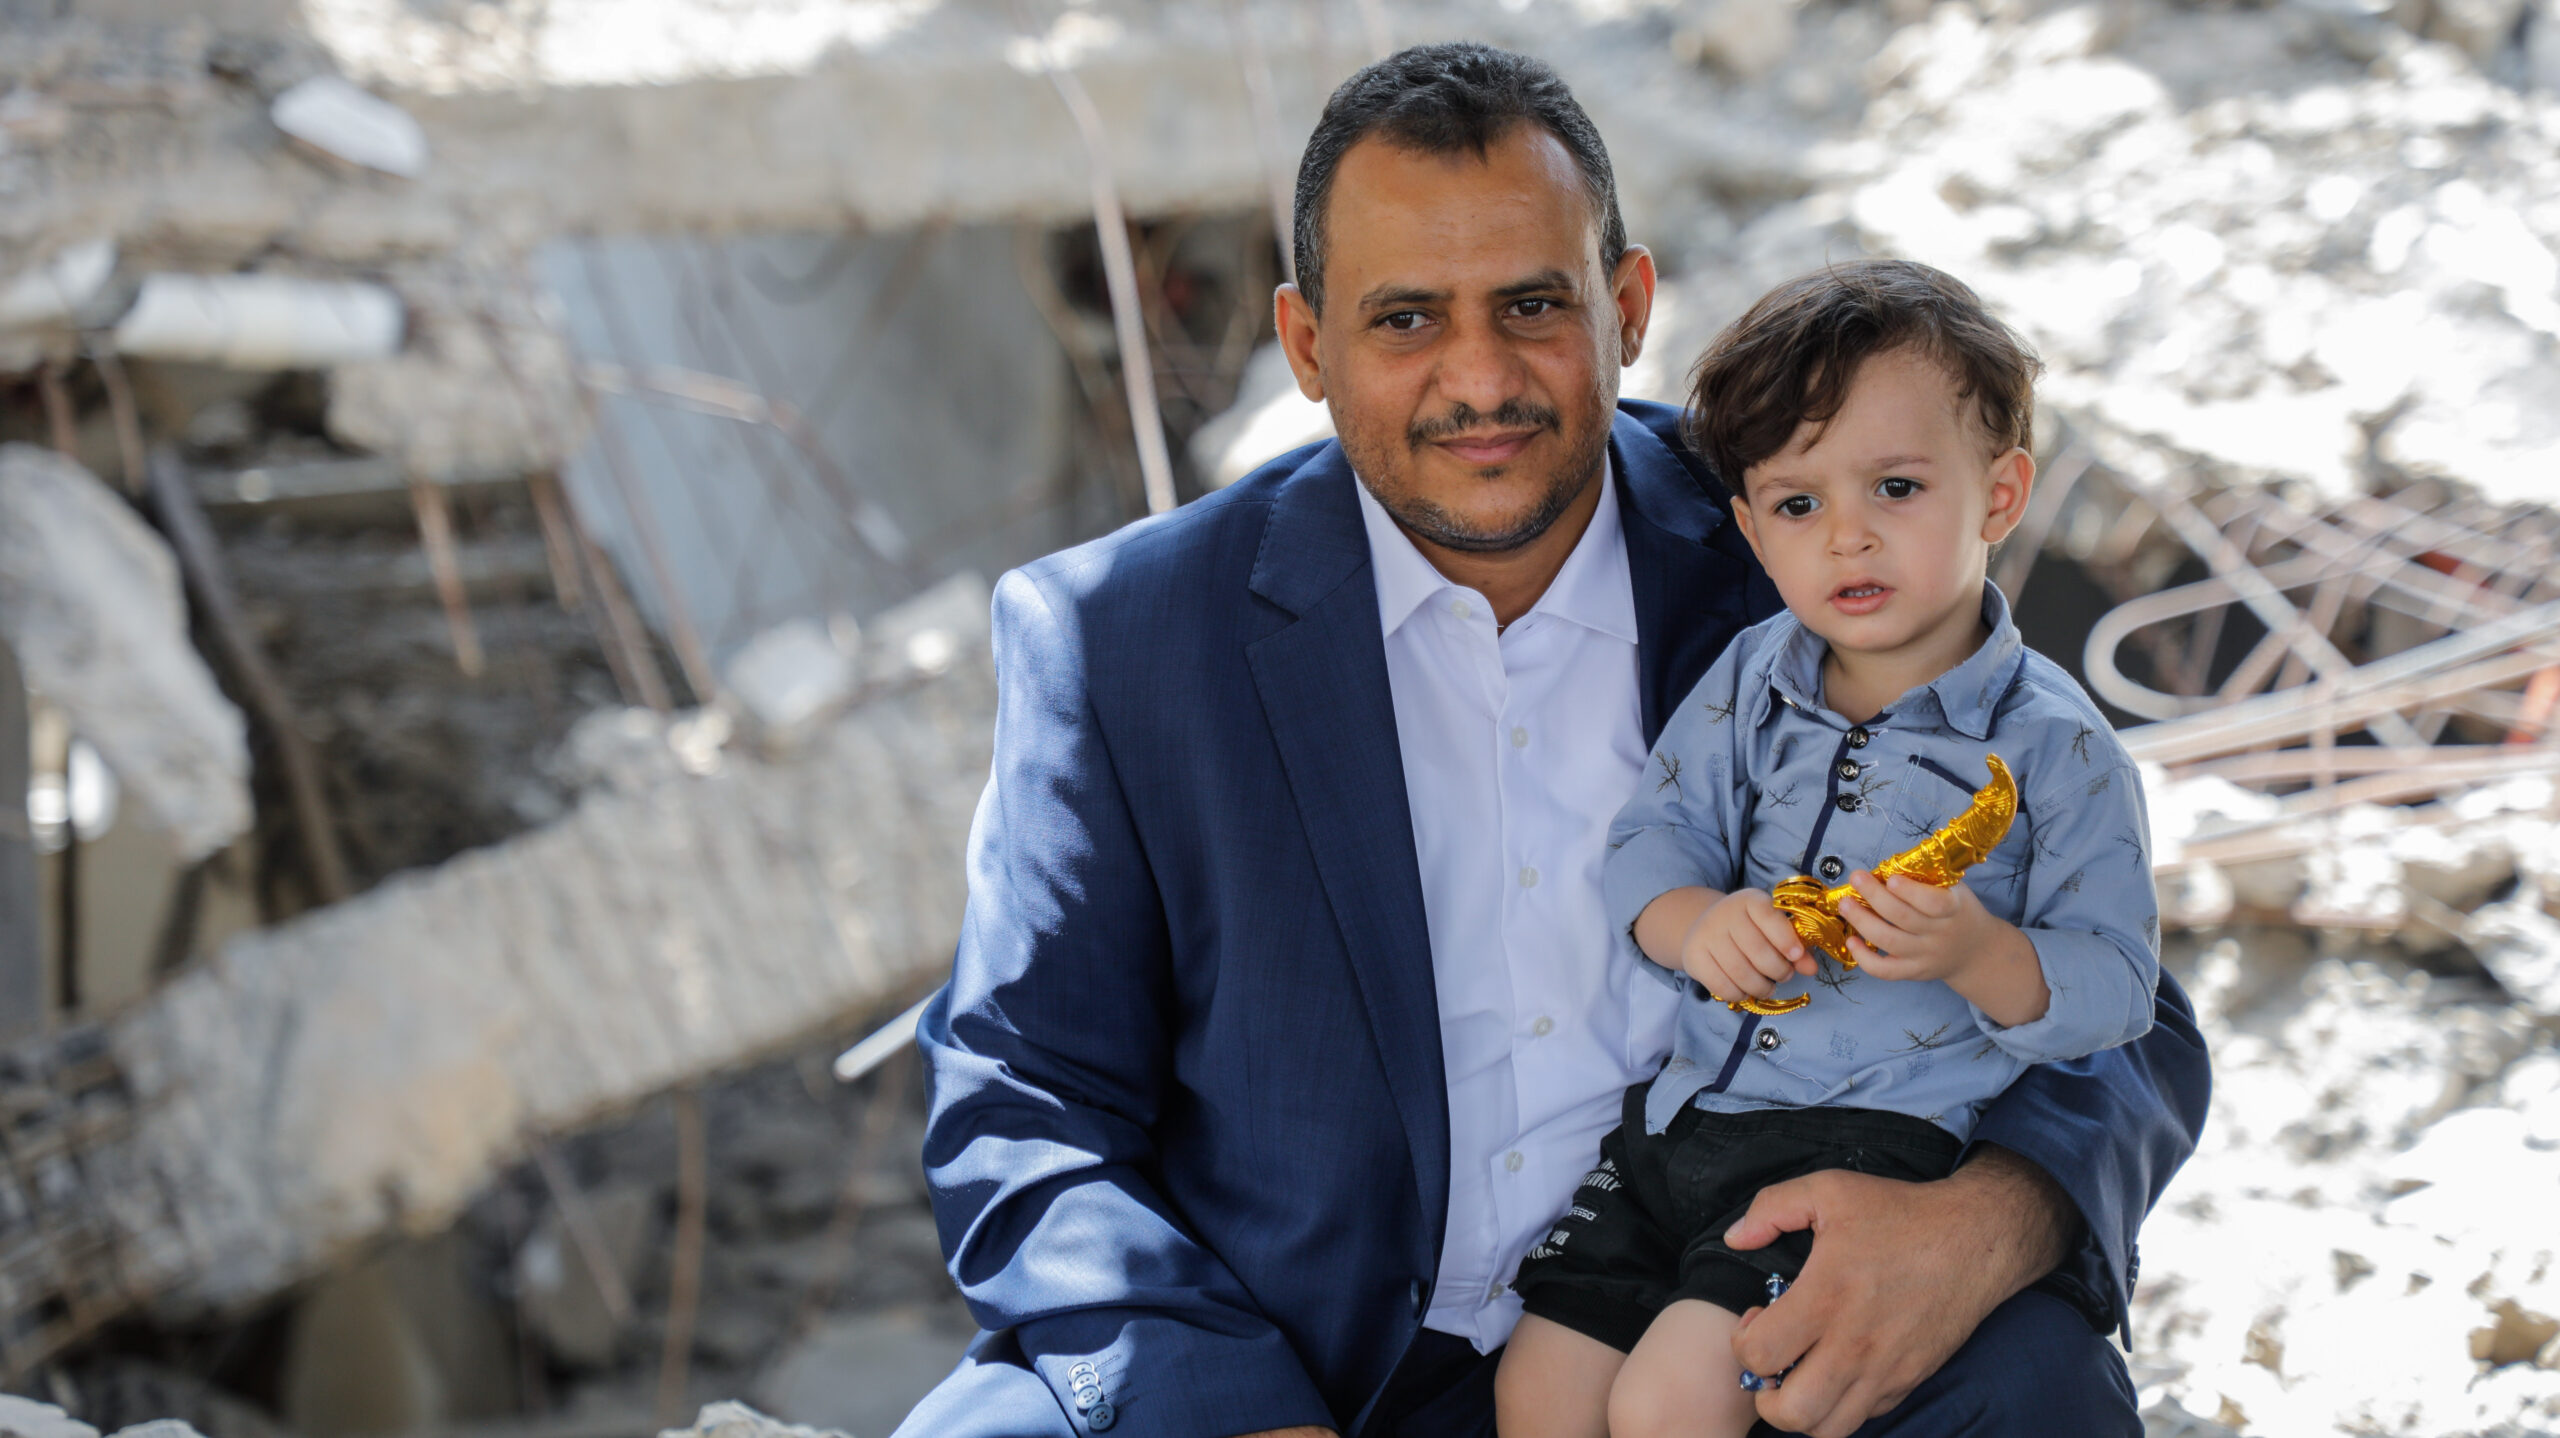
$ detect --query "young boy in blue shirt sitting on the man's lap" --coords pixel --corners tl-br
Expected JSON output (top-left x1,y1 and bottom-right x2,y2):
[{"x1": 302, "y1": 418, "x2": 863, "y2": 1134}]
[{"x1": 1495, "y1": 261, "x2": 2158, "y2": 1438}]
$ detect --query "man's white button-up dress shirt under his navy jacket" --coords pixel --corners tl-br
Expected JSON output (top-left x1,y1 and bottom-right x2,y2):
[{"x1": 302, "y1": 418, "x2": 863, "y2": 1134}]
[{"x1": 1359, "y1": 473, "x2": 1677, "y2": 1351}]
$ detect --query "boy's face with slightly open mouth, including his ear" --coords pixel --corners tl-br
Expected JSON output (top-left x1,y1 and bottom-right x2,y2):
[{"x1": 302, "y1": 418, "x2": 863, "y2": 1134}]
[{"x1": 1733, "y1": 351, "x2": 2035, "y2": 665}]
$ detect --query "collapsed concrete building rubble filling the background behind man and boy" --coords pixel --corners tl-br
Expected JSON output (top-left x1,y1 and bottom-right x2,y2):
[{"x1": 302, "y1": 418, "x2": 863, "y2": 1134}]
[{"x1": 0, "y1": 0, "x2": 2560, "y2": 1438}]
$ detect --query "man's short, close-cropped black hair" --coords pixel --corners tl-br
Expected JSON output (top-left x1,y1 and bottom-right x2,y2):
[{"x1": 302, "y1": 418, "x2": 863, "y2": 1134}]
[{"x1": 1290, "y1": 41, "x2": 1626, "y2": 315}]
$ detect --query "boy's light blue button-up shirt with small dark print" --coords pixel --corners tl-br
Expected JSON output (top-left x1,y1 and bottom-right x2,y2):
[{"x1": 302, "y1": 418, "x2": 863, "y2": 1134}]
[{"x1": 1600, "y1": 583, "x2": 2161, "y2": 1139}]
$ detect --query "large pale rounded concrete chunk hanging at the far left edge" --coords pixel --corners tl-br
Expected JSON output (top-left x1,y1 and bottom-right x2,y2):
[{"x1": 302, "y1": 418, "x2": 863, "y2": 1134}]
[{"x1": 0, "y1": 445, "x2": 251, "y2": 862}]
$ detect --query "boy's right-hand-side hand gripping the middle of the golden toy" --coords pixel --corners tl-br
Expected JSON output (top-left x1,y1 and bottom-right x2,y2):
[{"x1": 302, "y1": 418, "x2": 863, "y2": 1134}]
[{"x1": 1841, "y1": 870, "x2": 2051, "y2": 1029}]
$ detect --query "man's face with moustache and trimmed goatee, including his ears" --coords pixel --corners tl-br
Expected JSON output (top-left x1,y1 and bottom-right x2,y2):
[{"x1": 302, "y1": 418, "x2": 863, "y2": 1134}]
[{"x1": 1280, "y1": 123, "x2": 1654, "y2": 553}]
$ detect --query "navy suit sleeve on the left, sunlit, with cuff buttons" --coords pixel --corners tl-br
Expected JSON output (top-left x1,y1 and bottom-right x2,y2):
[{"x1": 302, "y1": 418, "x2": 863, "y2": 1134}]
[{"x1": 916, "y1": 573, "x2": 1336, "y2": 1438}]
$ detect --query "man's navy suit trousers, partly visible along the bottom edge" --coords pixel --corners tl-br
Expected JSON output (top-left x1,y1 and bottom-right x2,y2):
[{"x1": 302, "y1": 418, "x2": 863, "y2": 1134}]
[{"x1": 896, "y1": 1290, "x2": 2143, "y2": 1438}]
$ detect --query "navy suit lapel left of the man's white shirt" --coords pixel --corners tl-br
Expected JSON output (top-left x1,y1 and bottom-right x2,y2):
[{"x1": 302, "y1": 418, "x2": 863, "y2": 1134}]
[{"x1": 1247, "y1": 445, "x2": 1449, "y2": 1243}]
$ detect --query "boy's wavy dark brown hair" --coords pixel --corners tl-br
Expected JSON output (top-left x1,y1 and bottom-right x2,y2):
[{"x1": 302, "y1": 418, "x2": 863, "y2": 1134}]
[{"x1": 1684, "y1": 258, "x2": 2045, "y2": 494}]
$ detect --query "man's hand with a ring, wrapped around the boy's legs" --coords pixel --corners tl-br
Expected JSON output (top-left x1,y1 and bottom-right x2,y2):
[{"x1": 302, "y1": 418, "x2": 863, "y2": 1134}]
[{"x1": 1725, "y1": 1146, "x2": 2079, "y2": 1438}]
